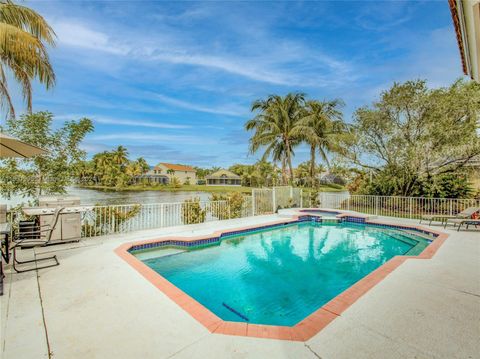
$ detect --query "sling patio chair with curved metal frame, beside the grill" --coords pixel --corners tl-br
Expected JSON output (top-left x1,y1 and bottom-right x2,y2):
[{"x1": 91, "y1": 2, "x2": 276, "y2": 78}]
[{"x1": 10, "y1": 208, "x2": 63, "y2": 273}]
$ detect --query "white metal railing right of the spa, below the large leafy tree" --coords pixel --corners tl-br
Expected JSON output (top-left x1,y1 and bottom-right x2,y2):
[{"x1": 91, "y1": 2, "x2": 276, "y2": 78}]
[{"x1": 320, "y1": 193, "x2": 480, "y2": 219}]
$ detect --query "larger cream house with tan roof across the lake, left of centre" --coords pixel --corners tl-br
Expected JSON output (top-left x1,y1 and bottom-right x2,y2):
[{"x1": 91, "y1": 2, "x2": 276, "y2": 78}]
[{"x1": 139, "y1": 162, "x2": 197, "y2": 184}]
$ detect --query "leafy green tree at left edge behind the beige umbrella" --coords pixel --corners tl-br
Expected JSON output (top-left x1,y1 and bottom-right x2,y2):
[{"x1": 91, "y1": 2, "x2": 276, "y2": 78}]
[{"x1": 0, "y1": 112, "x2": 93, "y2": 198}]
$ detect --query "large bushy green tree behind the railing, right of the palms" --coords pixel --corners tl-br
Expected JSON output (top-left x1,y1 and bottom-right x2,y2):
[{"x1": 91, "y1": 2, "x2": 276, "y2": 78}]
[{"x1": 343, "y1": 80, "x2": 480, "y2": 196}]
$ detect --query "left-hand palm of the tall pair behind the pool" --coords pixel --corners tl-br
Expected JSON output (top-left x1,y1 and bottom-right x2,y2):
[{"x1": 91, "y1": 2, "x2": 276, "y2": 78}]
[{"x1": 245, "y1": 93, "x2": 305, "y2": 183}]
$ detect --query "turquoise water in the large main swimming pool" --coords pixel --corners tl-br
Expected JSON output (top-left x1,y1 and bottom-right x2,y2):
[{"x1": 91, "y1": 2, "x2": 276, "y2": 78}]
[{"x1": 139, "y1": 222, "x2": 428, "y2": 326}]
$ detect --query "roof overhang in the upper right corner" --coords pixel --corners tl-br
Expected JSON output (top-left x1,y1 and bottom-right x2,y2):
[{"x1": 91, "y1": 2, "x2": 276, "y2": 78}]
[{"x1": 448, "y1": 0, "x2": 480, "y2": 82}]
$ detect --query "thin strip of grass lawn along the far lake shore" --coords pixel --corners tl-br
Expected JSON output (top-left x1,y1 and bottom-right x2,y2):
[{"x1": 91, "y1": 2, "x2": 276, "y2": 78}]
[{"x1": 80, "y1": 185, "x2": 345, "y2": 194}]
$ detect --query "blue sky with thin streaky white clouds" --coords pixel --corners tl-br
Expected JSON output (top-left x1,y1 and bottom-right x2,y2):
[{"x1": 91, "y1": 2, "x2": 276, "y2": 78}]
[{"x1": 6, "y1": 0, "x2": 462, "y2": 167}]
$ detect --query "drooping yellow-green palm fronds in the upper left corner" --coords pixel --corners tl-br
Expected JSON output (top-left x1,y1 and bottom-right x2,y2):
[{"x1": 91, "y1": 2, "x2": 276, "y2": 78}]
[{"x1": 0, "y1": 0, "x2": 55, "y2": 117}]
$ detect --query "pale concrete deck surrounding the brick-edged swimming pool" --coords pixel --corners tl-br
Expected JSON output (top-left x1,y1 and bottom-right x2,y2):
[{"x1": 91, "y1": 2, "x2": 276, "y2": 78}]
[{"x1": 0, "y1": 215, "x2": 480, "y2": 359}]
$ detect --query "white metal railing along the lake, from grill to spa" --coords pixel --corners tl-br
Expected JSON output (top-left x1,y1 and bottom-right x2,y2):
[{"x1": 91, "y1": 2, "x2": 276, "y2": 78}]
[{"x1": 6, "y1": 187, "x2": 302, "y2": 238}]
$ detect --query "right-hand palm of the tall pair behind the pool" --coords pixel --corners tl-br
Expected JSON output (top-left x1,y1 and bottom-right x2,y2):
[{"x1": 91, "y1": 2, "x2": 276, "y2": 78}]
[{"x1": 296, "y1": 99, "x2": 345, "y2": 187}]
